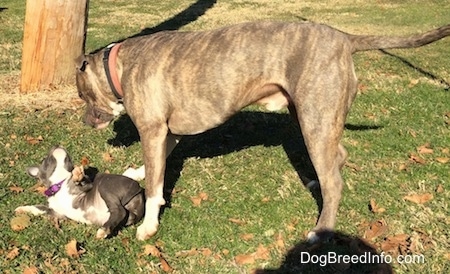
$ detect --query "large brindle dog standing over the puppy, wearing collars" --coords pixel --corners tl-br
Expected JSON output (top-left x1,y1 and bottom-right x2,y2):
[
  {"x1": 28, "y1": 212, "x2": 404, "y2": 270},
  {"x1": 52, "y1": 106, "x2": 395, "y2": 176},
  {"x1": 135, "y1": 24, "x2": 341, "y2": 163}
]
[{"x1": 76, "y1": 22, "x2": 450, "y2": 241}]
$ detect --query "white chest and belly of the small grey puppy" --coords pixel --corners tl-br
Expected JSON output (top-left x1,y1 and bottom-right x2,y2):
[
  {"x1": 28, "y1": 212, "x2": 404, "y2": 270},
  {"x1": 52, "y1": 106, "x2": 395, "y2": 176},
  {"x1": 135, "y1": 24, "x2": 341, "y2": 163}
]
[{"x1": 48, "y1": 185, "x2": 110, "y2": 225}]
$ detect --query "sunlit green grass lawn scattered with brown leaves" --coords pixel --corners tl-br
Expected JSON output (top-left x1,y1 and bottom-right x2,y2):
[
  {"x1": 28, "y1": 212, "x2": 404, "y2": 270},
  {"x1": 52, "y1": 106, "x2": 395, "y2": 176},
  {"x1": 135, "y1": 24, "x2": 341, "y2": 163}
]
[{"x1": 0, "y1": 0, "x2": 450, "y2": 273}]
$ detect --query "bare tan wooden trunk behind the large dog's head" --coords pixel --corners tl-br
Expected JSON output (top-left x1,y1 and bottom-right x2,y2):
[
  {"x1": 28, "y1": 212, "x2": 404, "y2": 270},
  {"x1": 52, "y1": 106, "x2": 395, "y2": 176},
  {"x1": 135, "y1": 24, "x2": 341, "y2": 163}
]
[{"x1": 20, "y1": 0, "x2": 88, "y2": 93}]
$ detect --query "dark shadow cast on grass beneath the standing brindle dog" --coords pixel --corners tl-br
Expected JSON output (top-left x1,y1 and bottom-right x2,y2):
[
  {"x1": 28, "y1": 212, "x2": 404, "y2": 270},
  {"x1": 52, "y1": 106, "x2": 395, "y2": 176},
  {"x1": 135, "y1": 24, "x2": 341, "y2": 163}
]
[{"x1": 108, "y1": 111, "x2": 380, "y2": 212}]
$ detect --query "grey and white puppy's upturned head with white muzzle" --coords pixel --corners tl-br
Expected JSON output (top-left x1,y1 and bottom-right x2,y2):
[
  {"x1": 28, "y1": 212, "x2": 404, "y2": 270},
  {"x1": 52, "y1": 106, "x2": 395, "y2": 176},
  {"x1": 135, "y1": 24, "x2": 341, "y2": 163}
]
[{"x1": 27, "y1": 146, "x2": 73, "y2": 187}]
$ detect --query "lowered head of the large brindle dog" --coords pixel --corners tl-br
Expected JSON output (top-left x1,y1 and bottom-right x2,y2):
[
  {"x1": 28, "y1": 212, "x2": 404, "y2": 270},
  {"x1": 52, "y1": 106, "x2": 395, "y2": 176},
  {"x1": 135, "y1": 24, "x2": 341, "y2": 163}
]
[{"x1": 76, "y1": 55, "x2": 123, "y2": 129}]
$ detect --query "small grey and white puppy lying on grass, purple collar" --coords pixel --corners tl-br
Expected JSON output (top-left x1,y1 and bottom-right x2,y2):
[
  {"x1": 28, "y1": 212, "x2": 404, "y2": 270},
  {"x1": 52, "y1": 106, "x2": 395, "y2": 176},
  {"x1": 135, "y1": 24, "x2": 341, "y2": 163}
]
[{"x1": 15, "y1": 146, "x2": 145, "y2": 238}]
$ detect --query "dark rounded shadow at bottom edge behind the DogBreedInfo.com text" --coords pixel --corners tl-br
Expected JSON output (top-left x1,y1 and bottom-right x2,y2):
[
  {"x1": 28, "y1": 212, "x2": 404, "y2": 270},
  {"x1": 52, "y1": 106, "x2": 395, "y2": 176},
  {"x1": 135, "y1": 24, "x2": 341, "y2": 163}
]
[{"x1": 253, "y1": 232, "x2": 394, "y2": 274}]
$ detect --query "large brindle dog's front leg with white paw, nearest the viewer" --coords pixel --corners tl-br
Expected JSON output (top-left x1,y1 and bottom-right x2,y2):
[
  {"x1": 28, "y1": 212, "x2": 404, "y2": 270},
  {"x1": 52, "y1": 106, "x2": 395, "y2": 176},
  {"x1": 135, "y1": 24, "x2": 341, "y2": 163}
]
[{"x1": 136, "y1": 123, "x2": 168, "y2": 240}]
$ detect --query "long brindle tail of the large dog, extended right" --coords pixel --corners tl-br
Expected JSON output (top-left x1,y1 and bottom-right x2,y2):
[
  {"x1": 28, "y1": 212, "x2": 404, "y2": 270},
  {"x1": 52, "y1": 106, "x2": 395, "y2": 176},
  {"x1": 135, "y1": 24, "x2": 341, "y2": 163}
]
[{"x1": 349, "y1": 25, "x2": 450, "y2": 52}]
